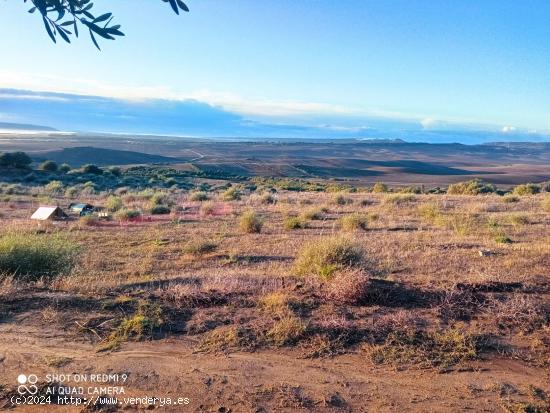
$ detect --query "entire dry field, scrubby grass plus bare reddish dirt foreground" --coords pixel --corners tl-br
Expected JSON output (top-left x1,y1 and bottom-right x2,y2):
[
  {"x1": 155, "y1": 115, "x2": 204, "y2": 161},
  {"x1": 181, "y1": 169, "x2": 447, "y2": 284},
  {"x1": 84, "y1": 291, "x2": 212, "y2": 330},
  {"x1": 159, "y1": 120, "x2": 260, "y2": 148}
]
[{"x1": 0, "y1": 185, "x2": 550, "y2": 413}]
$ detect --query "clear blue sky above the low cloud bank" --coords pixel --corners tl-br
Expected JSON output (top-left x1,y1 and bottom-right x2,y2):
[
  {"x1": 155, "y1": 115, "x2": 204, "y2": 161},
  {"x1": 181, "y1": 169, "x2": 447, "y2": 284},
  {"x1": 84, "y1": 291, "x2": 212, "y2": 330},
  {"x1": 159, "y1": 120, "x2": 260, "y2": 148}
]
[{"x1": 0, "y1": 0, "x2": 550, "y2": 139}]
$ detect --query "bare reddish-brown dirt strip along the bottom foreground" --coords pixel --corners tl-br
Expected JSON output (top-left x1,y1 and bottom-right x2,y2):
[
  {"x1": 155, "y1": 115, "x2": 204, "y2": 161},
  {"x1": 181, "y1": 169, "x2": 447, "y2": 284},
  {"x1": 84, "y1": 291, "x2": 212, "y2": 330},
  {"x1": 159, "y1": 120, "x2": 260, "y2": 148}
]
[{"x1": 0, "y1": 325, "x2": 548, "y2": 412}]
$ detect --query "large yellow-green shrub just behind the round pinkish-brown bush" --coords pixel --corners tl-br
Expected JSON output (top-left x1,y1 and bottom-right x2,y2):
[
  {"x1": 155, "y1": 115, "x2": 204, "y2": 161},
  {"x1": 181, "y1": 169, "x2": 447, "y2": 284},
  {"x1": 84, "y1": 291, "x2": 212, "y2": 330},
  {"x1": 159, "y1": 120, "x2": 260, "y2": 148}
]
[{"x1": 294, "y1": 236, "x2": 365, "y2": 278}]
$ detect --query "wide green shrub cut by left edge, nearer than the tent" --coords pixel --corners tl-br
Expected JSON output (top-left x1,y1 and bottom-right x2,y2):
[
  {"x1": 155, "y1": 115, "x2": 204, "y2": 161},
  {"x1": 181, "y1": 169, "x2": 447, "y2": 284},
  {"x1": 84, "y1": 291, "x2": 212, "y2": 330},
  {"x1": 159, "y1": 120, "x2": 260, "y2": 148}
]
[{"x1": 0, "y1": 233, "x2": 78, "y2": 280}]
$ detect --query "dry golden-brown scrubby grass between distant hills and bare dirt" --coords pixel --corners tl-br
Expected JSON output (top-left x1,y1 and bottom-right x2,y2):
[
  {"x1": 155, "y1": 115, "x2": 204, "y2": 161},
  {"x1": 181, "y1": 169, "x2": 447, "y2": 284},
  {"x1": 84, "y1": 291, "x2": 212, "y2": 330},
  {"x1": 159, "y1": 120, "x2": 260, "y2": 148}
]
[{"x1": 0, "y1": 187, "x2": 550, "y2": 376}]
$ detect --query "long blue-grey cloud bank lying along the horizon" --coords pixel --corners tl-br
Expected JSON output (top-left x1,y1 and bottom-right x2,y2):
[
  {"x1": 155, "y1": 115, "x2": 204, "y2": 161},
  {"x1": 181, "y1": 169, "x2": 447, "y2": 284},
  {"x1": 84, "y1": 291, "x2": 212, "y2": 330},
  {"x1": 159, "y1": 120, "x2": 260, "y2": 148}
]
[{"x1": 0, "y1": 88, "x2": 550, "y2": 143}]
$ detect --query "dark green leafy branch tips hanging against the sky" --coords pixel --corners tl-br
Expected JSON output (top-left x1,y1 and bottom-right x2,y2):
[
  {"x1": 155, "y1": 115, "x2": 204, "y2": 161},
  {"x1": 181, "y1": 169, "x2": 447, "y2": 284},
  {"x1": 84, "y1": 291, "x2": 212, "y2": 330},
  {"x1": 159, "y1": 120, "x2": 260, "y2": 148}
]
[{"x1": 23, "y1": 0, "x2": 189, "y2": 50}]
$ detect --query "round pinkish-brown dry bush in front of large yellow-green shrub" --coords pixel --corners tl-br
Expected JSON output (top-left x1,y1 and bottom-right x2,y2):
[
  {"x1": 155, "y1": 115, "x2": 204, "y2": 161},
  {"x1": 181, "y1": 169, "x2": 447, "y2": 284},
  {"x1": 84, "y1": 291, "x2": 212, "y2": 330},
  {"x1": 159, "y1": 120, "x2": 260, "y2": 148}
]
[{"x1": 324, "y1": 269, "x2": 370, "y2": 305}]
